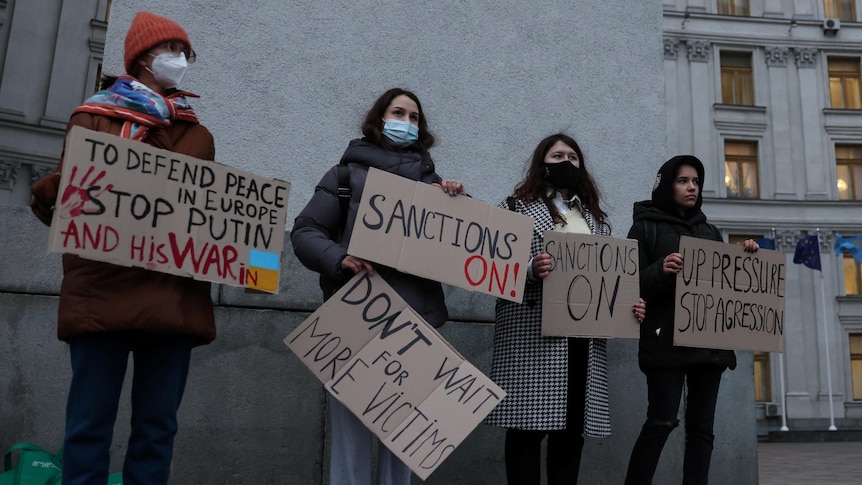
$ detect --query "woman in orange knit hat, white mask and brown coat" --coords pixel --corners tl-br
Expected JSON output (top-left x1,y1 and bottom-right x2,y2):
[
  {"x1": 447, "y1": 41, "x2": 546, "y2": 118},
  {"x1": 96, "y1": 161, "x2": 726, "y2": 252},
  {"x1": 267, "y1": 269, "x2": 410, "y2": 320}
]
[{"x1": 34, "y1": 12, "x2": 216, "y2": 485}]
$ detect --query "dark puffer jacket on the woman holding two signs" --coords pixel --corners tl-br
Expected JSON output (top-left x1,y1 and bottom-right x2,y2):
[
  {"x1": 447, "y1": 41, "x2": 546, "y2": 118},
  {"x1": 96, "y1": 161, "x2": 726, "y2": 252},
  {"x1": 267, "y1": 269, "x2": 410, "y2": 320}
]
[{"x1": 290, "y1": 140, "x2": 449, "y2": 327}]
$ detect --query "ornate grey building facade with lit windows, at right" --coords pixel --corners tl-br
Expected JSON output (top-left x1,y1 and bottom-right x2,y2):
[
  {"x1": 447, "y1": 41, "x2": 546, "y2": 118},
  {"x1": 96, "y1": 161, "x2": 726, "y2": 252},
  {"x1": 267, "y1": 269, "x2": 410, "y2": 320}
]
[{"x1": 663, "y1": 0, "x2": 862, "y2": 433}]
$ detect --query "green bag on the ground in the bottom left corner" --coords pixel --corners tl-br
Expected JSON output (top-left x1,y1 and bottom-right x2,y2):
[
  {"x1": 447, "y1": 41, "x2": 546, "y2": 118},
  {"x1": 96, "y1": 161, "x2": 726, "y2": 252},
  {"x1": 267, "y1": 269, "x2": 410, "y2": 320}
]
[{"x1": 0, "y1": 443, "x2": 63, "y2": 485}]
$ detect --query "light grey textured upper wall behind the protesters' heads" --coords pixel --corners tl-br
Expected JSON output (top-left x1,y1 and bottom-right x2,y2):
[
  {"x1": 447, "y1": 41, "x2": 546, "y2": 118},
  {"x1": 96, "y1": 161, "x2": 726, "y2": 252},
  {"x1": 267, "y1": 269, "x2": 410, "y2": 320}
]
[{"x1": 103, "y1": 0, "x2": 668, "y2": 235}]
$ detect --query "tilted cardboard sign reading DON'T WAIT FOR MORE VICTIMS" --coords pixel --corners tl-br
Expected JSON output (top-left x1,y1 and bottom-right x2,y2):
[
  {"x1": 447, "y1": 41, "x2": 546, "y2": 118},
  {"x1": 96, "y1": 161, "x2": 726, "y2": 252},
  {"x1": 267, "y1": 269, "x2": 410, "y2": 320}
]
[{"x1": 284, "y1": 272, "x2": 506, "y2": 479}]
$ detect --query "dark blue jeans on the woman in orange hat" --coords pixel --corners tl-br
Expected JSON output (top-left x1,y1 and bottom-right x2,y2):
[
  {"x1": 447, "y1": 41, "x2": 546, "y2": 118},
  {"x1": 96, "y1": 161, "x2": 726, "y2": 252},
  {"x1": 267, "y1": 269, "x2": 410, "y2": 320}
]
[{"x1": 63, "y1": 332, "x2": 195, "y2": 485}]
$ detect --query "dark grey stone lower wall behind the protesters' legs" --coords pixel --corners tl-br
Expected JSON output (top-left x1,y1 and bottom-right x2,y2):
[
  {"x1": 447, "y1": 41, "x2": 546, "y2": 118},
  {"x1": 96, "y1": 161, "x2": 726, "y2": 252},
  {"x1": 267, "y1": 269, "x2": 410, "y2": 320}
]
[{"x1": 0, "y1": 201, "x2": 757, "y2": 485}]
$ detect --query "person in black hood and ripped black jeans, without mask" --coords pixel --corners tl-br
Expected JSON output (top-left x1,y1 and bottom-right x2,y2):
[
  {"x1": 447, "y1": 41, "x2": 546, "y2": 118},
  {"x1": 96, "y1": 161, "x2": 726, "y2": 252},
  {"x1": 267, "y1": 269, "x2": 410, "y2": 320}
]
[{"x1": 625, "y1": 155, "x2": 757, "y2": 485}]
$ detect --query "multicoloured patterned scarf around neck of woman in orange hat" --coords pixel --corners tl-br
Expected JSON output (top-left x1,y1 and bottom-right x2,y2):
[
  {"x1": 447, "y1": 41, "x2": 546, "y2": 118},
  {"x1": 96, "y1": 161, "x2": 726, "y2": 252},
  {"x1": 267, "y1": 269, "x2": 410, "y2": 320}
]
[{"x1": 72, "y1": 74, "x2": 198, "y2": 141}]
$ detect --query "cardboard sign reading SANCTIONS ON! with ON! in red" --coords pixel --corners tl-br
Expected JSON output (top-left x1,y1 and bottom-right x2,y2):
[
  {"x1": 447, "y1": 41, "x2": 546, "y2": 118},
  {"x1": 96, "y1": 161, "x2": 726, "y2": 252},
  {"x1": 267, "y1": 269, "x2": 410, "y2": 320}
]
[{"x1": 347, "y1": 168, "x2": 533, "y2": 302}]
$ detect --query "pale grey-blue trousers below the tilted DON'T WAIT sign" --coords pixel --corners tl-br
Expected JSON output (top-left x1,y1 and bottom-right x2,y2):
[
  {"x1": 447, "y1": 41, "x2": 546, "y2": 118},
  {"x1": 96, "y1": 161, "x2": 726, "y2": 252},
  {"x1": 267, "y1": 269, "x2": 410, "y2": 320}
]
[{"x1": 329, "y1": 395, "x2": 411, "y2": 485}]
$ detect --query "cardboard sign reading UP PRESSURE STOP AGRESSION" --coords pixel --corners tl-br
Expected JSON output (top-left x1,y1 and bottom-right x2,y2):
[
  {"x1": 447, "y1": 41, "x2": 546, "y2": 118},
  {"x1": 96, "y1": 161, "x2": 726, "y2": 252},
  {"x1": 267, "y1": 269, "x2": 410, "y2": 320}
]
[{"x1": 676, "y1": 236, "x2": 787, "y2": 352}]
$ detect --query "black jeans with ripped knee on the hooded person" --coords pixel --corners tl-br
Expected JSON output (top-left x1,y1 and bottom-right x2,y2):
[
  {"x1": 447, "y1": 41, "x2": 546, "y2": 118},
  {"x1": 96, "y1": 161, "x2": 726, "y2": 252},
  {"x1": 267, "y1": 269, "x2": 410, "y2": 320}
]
[{"x1": 625, "y1": 366, "x2": 724, "y2": 485}]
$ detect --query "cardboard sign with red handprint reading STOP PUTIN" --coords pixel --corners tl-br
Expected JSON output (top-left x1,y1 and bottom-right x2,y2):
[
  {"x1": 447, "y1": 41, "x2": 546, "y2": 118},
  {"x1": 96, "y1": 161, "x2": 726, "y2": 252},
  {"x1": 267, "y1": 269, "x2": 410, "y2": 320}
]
[{"x1": 48, "y1": 127, "x2": 290, "y2": 293}]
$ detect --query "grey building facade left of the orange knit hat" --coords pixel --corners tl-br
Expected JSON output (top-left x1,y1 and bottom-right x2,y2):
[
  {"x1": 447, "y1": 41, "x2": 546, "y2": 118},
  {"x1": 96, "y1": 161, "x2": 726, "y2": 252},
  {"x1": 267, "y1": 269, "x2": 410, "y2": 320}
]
[{"x1": 0, "y1": 0, "x2": 110, "y2": 204}]
